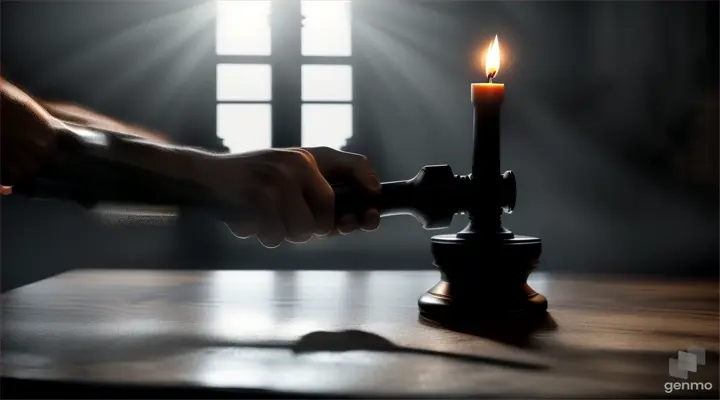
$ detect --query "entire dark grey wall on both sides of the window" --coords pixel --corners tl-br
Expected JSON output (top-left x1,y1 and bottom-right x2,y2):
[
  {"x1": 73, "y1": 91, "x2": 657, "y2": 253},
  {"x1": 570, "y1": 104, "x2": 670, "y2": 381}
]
[{"x1": 0, "y1": 0, "x2": 718, "y2": 289}]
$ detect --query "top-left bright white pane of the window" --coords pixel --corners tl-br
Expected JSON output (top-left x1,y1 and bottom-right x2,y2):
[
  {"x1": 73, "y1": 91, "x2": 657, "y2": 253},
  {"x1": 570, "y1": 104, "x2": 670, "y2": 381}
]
[{"x1": 216, "y1": 0, "x2": 271, "y2": 56}]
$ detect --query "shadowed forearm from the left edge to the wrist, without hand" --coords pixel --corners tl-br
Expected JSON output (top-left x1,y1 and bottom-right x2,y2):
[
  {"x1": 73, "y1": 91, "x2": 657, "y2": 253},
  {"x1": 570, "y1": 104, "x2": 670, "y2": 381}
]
[{"x1": 0, "y1": 76, "x2": 225, "y2": 211}]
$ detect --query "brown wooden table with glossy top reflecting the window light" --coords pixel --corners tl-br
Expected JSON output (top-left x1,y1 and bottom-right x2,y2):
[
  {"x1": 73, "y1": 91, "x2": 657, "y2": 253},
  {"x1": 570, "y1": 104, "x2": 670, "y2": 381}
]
[{"x1": 2, "y1": 270, "x2": 719, "y2": 398}]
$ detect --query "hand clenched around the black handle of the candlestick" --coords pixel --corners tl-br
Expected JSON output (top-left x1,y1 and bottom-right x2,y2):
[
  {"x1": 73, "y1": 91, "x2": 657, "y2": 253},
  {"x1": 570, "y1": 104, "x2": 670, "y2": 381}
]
[{"x1": 201, "y1": 147, "x2": 380, "y2": 248}]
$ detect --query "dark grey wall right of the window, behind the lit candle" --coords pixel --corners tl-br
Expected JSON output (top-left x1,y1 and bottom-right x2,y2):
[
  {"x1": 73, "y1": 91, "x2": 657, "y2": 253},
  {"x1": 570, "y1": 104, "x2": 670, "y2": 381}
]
[{"x1": 348, "y1": 1, "x2": 718, "y2": 273}]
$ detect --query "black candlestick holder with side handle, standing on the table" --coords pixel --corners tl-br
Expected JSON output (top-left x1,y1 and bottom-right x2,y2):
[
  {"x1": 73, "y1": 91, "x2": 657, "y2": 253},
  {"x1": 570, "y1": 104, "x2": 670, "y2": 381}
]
[{"x1": 335, "y1": 86, "x2": 547, "y2": 328}]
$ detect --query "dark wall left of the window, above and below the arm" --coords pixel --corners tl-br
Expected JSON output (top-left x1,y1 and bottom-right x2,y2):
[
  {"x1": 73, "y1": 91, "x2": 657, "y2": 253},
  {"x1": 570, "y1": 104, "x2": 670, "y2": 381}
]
[{"x1": 0, "y1": 0, "x2": 215, "y2": 289}]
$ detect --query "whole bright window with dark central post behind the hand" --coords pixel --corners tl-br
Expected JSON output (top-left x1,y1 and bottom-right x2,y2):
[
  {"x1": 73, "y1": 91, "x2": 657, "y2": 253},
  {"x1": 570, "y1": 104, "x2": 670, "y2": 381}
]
[{"x1": 216, "y1": 0, "x2": 353, "y2": 153}]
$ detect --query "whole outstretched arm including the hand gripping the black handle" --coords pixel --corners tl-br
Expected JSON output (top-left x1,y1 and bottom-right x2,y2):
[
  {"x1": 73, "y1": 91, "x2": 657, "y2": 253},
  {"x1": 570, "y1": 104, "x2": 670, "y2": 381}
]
[{"x1": 0, "y1": 76, "x2": 379, "y2": 247}]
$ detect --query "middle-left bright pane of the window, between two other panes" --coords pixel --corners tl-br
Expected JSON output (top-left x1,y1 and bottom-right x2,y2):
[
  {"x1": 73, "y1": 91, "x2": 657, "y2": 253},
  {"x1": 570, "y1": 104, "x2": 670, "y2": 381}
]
[{"x1": 217, "y1": 64, "x2": 272, "y2": 101}]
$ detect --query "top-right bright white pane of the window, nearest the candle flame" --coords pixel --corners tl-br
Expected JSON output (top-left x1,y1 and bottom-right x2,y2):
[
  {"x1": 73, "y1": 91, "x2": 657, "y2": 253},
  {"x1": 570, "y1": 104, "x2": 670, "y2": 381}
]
[{"x1": 301, "y1": 0, "x2": 352, "y2": 57}]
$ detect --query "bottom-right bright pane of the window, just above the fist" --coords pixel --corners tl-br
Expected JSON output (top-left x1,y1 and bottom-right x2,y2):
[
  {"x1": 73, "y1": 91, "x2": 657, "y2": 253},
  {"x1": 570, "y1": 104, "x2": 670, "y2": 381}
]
[{"x1": 302, "y1": 104, "x2": 353, "y2": 150}]
